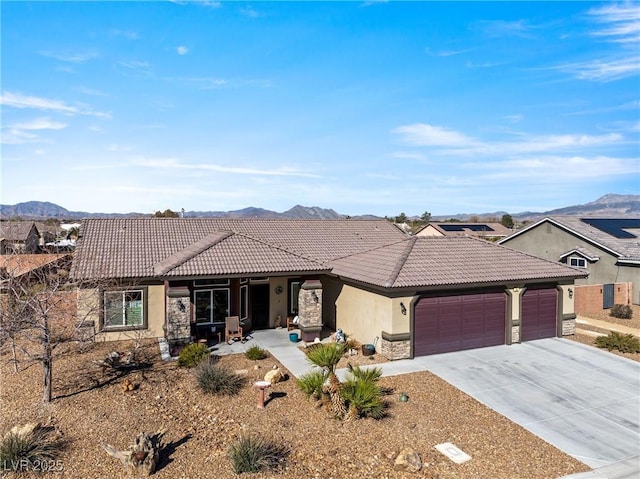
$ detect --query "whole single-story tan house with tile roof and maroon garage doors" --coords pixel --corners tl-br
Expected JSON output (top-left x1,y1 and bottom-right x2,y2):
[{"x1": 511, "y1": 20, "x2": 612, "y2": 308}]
[{"x1": 71, "y1": 218, "x2": 586, "y2": 359}]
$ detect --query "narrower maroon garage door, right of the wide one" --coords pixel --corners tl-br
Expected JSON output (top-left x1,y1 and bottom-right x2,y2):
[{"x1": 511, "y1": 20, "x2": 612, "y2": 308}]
[{"x1": 520, "y1": 288, "x2": 558, "y2": 341}]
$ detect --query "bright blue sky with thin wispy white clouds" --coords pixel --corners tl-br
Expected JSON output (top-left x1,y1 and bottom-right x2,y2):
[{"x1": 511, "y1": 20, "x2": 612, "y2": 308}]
[{"x1": 0, "y1": 1, "x2": 640, "y2": 216}]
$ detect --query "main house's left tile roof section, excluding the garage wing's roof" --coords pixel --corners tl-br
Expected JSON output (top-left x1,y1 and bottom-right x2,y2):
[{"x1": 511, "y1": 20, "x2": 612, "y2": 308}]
[{"x1": 72, "y1": 218, "x2": 406, "y2": 278}]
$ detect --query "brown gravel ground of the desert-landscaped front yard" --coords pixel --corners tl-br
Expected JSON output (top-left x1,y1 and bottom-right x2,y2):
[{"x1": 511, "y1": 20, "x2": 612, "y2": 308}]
[{"x1": 0, "y1": 342, "x2": 589, "y2": 479}]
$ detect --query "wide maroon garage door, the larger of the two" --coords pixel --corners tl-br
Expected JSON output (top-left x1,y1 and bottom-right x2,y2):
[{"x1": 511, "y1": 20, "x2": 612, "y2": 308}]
[{"x1": 413, "y1": 292, "x2": 506, "y2": 356}]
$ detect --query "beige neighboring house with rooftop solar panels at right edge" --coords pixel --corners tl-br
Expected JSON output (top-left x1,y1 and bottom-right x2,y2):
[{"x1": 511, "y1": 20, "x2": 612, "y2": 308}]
[{"x1": 500, "y1": 216, "x2": 640, "y2": 312}]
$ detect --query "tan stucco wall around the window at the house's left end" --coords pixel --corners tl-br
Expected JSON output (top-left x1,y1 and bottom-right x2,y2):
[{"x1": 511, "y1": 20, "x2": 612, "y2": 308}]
[{"x1": 78, "y1": 285, "x2": 165, "y2": 341}]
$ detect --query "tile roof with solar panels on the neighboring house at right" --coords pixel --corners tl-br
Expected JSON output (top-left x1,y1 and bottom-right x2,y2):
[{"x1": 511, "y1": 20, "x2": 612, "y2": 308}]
[{"x1": 500, "y1": 216, "x2": 640, "y2": 263}]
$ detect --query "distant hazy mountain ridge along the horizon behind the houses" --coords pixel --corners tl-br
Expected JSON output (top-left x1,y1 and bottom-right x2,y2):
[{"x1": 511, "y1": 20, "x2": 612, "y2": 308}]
[{"x1": 0, "y1": 194, "x2": 640, "y2": 221}]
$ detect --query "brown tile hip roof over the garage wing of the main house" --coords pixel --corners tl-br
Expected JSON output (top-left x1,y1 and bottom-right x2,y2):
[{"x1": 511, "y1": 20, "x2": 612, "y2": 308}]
[{"x1": 331, "y1": 237, "x2": 587, "y2": 288}]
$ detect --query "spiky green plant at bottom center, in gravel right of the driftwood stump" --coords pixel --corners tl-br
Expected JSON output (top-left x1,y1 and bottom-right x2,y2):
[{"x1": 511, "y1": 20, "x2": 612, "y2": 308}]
[{"x1": 229, "y1": 435, "x2": 289, "y2": 474}]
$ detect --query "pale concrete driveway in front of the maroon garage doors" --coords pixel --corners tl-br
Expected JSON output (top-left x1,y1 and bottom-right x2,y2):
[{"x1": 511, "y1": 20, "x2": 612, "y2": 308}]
[{"x1": 414, "y1": 338, "x2": 640, "y2": 470}]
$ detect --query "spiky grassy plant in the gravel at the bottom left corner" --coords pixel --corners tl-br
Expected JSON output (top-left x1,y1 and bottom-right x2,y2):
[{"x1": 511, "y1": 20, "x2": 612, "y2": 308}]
[{"x1": 0, "y1": 424, "x2": 66, "y2": 469}]
